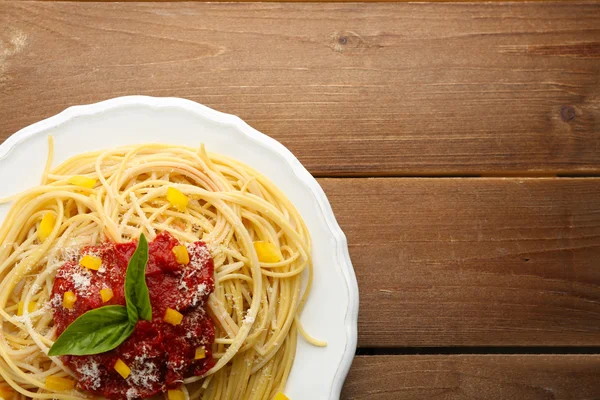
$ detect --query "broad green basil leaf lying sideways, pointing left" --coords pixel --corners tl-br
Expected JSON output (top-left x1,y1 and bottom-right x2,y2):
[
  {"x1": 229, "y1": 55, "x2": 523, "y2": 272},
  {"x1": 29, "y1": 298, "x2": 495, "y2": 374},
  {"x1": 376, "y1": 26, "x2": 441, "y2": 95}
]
[{"x1": 48, "y1": 306, "x2": 135, "y2": 356}]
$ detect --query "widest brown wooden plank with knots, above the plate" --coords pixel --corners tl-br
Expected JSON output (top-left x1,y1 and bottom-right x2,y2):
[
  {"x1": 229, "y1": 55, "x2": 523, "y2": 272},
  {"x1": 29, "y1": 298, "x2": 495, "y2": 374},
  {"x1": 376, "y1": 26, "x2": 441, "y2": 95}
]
[{"x1": 0, "y1": 1, "x2": 600, "y2": 176}]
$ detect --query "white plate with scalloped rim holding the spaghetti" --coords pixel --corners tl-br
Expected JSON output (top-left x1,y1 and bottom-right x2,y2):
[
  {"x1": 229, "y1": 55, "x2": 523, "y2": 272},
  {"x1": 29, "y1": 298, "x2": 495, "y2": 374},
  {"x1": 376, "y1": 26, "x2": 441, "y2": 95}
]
[{"x1": 0, "y1": 96, "x2": 358, "y2": 400}]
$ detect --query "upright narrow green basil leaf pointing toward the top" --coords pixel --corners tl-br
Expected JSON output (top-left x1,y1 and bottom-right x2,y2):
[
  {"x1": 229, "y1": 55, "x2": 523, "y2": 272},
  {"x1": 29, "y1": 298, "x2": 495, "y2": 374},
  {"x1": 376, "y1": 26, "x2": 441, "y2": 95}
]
[{"x1": 125, "y1": 234, "x2": 152, "y2": 325}]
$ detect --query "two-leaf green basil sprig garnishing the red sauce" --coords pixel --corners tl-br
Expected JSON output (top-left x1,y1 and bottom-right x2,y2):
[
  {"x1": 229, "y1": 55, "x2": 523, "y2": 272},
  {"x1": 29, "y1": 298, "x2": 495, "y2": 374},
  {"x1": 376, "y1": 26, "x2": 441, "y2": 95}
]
[{"x1": 48, "y1": 234, "x2": 152, "y2": 356}]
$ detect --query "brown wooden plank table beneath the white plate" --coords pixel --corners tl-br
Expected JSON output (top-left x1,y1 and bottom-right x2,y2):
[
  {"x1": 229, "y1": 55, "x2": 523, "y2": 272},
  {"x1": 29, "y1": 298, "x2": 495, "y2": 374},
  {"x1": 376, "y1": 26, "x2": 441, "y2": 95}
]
[{"x1": 0, "y1": 0, "x2": 600, "y2": 400}]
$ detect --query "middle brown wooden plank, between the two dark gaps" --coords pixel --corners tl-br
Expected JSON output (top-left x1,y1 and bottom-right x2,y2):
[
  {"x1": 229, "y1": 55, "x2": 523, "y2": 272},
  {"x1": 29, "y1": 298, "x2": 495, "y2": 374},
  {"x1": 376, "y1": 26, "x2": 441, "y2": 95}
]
[{"x1": 320, "y1": 178, "x2": 600, "y2": 347}]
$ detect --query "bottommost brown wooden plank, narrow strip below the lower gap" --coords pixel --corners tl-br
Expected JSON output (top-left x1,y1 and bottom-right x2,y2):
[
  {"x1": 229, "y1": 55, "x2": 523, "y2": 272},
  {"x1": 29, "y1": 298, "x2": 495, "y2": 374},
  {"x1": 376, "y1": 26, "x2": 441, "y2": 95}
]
[{"x1": 341, "y1": 355, "x2": 600, "y2": 400}]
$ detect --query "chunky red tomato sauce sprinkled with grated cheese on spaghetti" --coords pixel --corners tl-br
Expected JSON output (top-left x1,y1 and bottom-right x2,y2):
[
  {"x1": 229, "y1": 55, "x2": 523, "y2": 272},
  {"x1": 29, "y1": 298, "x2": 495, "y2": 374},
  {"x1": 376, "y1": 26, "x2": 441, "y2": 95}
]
[{"x1": 51, "y1": 233, "x2": 215, "y2": 399}]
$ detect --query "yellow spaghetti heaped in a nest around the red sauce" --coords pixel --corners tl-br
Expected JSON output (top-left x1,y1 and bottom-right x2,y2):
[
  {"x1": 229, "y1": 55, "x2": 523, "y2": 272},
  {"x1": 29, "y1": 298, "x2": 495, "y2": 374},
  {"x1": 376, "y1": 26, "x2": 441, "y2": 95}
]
[{"x1": 0, "y1": 139, "x2": 325, "y2": 400}]
